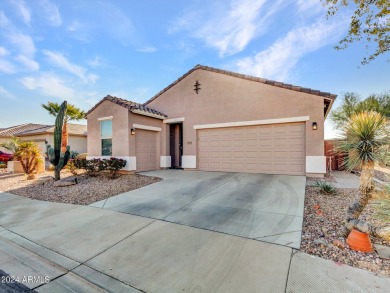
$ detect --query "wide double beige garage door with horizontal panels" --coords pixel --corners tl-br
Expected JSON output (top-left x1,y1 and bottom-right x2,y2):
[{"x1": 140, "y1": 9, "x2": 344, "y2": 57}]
[{"x1": 198, "y1": 123, "x2": 305, "y2": 175}]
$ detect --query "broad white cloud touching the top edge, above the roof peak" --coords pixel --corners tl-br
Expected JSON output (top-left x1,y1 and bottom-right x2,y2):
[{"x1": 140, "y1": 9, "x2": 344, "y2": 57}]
[{"x1": 168, "y1": 0, "x2": 289, "y2": 56}]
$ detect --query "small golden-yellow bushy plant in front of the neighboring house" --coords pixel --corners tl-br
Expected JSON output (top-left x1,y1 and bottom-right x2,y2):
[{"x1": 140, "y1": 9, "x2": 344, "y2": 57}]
[{"x1": 14, "y1": 141, "x2": 40, "y2": 180}]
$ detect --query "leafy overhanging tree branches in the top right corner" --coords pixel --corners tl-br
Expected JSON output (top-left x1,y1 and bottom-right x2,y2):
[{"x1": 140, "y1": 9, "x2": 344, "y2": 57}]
[{"x1": 321, "y1": 0, "x2": 390, "y2": 64}]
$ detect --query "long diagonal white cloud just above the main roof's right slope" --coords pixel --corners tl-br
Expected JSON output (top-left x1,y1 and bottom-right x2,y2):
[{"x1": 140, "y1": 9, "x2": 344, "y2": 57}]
[{"x1": 235, "y1": 20, "x2": 340, "y2": 81}]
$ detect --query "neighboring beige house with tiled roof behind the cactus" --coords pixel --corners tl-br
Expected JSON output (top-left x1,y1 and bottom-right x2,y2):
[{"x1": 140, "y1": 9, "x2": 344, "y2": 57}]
[{"x1": 0, "y1": 123, "x2": 87, "y2": 154}]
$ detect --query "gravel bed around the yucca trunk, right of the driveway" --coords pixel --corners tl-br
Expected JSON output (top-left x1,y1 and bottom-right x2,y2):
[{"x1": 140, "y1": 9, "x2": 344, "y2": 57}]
[{"x1": 301, "y1": 186, "x2": 390, "y2": 277}]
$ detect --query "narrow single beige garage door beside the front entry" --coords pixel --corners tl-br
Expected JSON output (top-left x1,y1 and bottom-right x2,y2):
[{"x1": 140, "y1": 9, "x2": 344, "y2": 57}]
[{"x1": 135, "y1": 129, "x2": 157, "y2": 171}]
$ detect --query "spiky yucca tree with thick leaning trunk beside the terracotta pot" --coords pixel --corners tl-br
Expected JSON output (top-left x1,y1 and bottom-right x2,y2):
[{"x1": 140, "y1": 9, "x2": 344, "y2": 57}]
[{"x1": 335, "y1": 111, "x2": 390, "y2": 241}]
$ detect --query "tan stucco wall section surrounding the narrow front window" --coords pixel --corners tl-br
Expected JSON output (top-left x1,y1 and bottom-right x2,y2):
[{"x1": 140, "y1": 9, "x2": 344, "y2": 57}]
[{"x1": 87, "y1": 101, "x2": 130, "y2": 157}]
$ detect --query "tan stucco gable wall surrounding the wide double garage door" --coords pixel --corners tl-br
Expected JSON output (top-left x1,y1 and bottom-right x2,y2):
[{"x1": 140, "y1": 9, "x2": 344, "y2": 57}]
[{"x1": 147, "y1": 70, "x2": 324, "y2": 173}]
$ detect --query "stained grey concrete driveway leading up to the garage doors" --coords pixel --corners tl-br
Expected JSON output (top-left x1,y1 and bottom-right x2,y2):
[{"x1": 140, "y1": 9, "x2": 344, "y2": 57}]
[{"x1": 91, "y1": 170, "x2": 306, "y2": 249}]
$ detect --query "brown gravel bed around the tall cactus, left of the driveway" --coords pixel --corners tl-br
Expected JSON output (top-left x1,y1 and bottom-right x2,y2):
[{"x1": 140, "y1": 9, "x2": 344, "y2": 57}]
[{"x1": 0, "y1": 170, "x2": 162, "y2": 205}]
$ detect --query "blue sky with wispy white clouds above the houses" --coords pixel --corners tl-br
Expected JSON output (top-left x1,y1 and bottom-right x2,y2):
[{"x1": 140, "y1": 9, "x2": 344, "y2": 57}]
[{"x1": 0, "y1": 0, "x2": 390, "y2": 137}]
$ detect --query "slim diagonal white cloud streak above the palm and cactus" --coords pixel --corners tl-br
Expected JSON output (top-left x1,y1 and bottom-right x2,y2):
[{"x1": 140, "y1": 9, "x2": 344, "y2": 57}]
[{"x1": 43, "y1": 50, "x2": 98, "y2": 83}]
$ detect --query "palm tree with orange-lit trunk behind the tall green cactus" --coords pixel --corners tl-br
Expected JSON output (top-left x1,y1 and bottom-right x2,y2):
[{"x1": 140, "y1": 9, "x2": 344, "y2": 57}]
[{"x1": 42, "y1": 102, "x2": 85, "y2": 152}]
